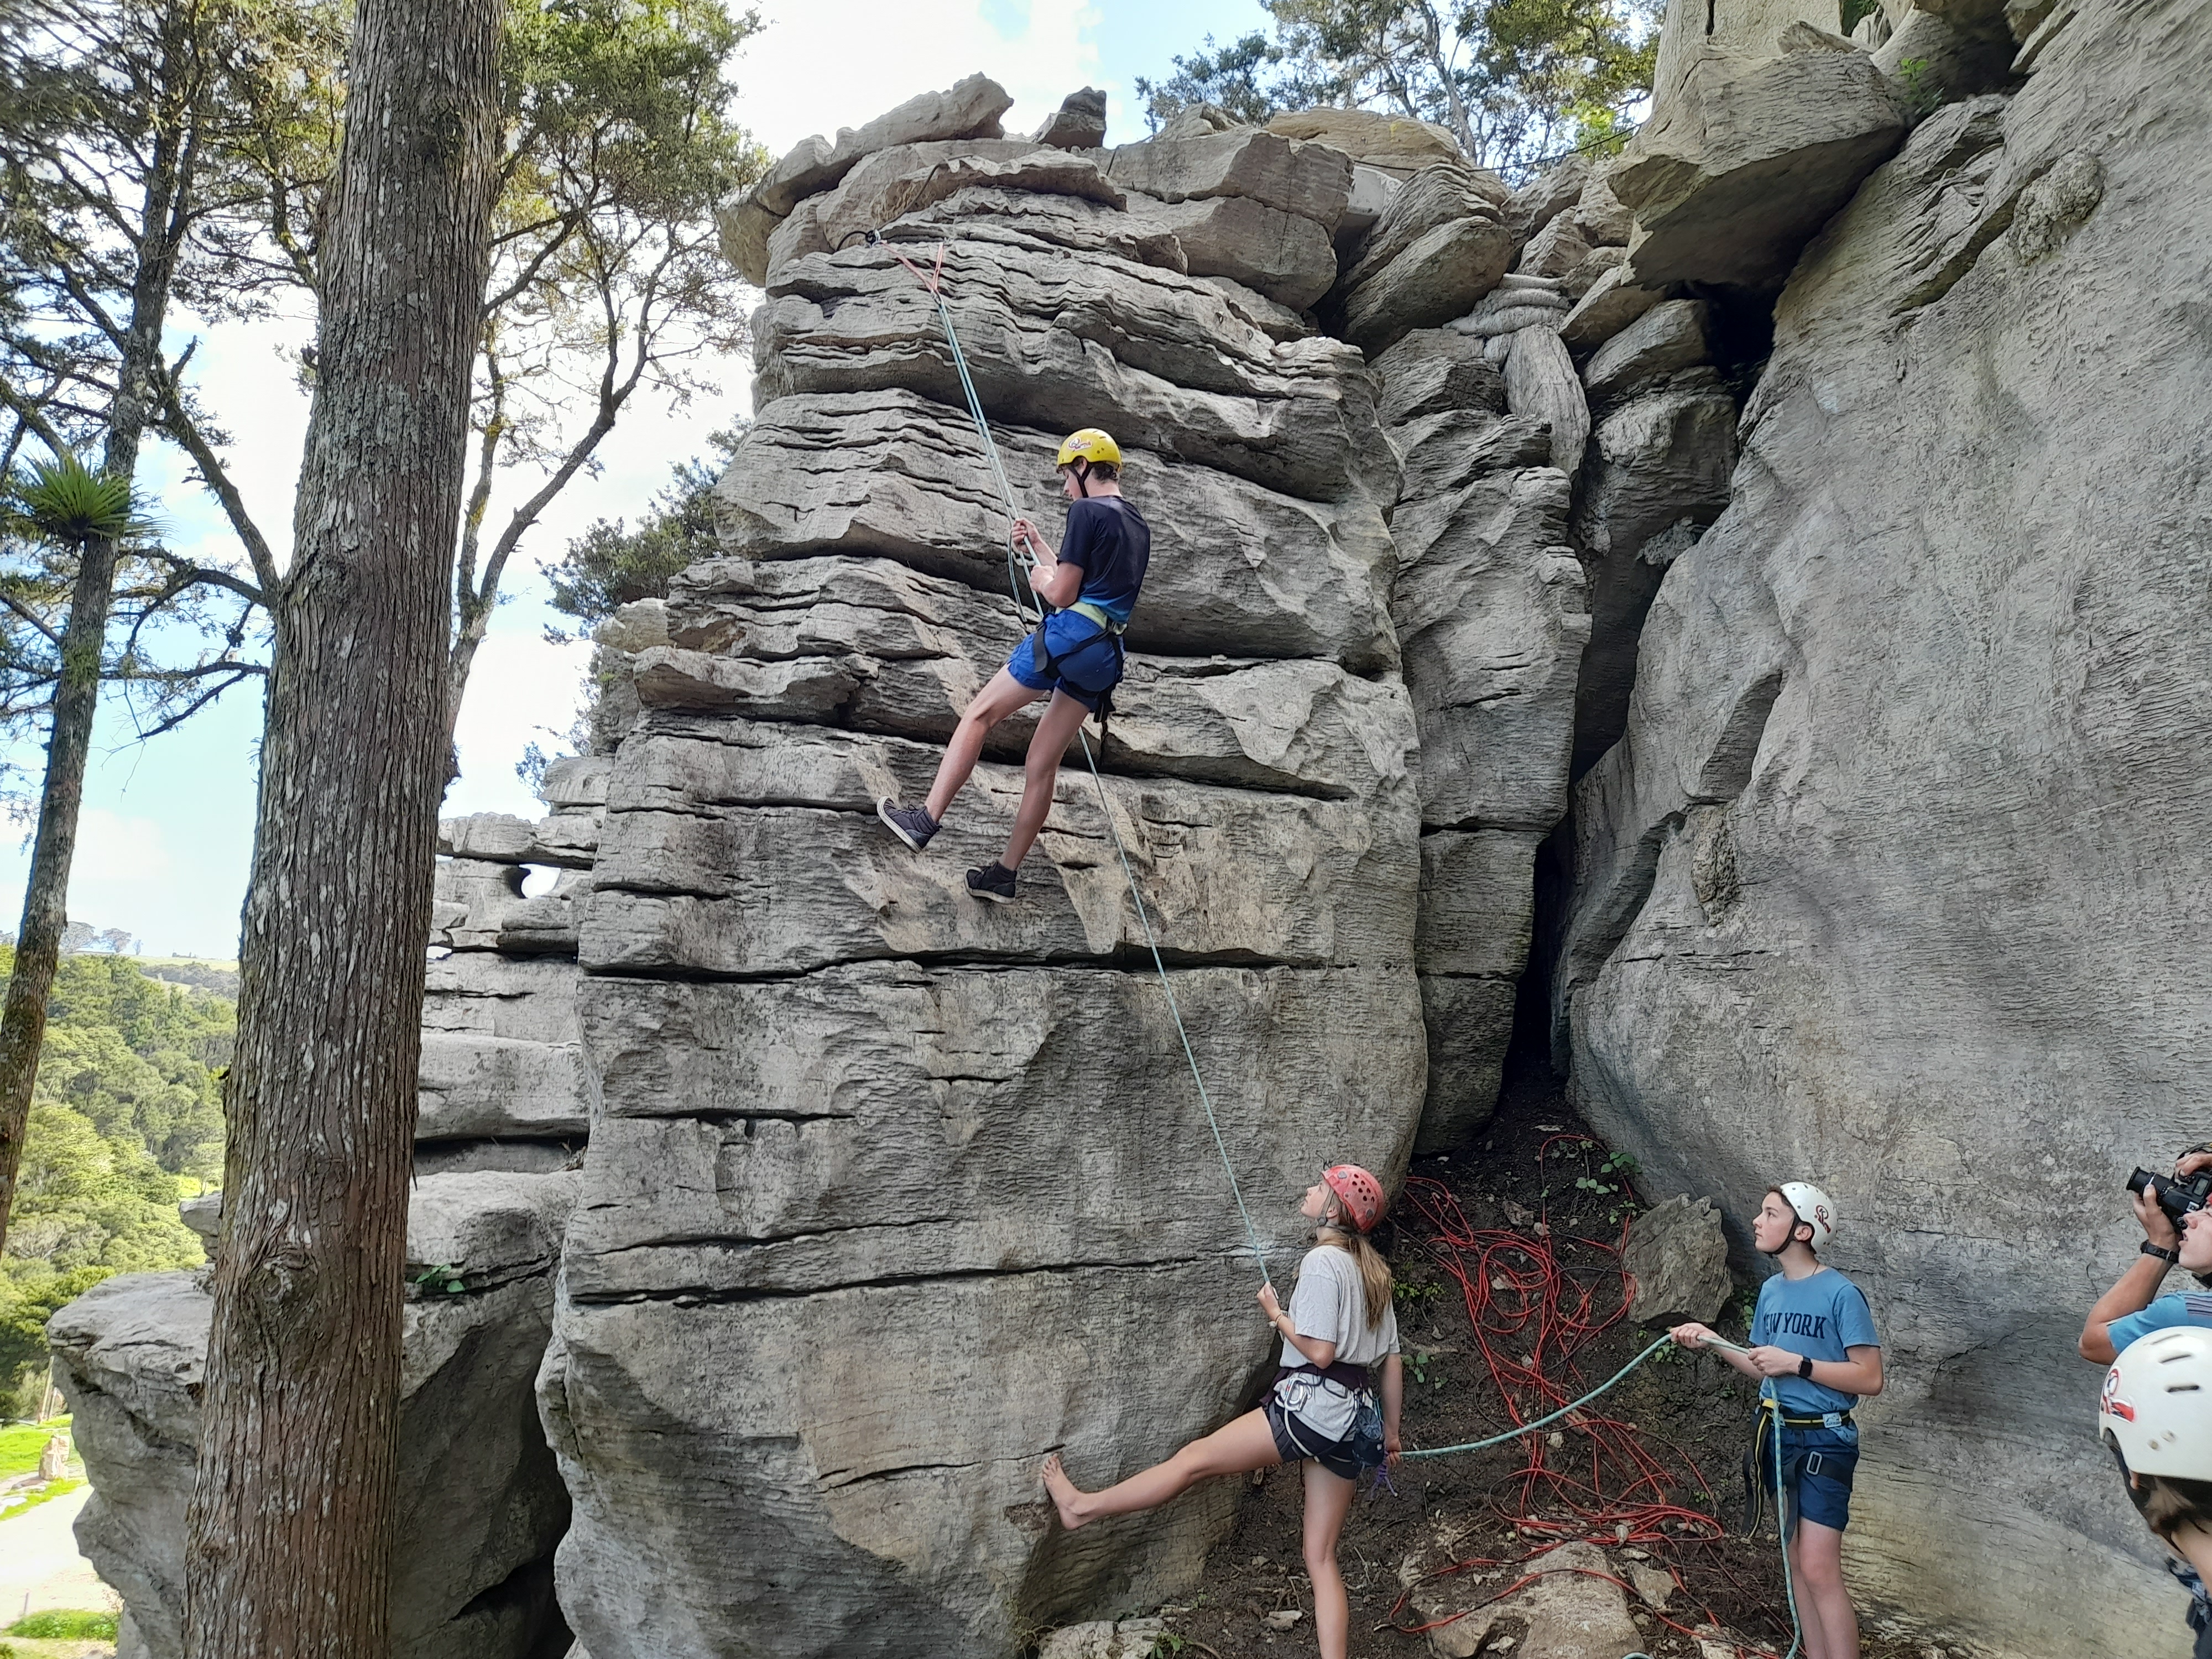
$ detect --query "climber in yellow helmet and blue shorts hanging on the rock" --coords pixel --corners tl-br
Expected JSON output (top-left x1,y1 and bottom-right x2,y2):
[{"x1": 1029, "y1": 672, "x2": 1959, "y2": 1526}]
[{"x1": 876, "y1": 427, "x2": 1152, "y2": 905}]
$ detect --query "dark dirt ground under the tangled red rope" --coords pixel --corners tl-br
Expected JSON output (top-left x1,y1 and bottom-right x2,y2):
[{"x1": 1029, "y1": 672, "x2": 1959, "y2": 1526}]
[{"x1": 1159, "y1": 1064, "x2": 1975, "y2": 1659}]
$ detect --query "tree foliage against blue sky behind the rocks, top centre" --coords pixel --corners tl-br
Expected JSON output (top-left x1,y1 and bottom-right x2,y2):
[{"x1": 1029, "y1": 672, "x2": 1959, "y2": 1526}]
[{"x1": 1137, "y1": 0, "x2": 1661, "y2": 179}]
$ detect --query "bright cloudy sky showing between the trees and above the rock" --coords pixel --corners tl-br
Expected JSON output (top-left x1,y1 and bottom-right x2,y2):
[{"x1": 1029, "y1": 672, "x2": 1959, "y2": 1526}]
[{"x1": 0, "y1": 0, "x2": 1267, "y2": 956}]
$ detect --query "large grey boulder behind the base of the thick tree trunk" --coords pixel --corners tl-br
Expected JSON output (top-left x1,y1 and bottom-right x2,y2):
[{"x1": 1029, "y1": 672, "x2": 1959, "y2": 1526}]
[{"x1": 49, "y1": 1172, "x2": 577, "y2": 1659}]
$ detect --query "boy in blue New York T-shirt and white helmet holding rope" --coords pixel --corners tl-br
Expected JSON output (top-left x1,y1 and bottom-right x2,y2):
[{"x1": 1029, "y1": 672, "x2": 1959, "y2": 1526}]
[{"x1": 1670, "y1": 1181, "x2": 1882, "y2": 1659}]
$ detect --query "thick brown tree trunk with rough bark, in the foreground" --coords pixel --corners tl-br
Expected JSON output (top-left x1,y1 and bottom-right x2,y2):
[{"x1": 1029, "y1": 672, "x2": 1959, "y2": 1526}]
[{"x1": 186, "y1": 0, "x2": 502, "y2": 1659}]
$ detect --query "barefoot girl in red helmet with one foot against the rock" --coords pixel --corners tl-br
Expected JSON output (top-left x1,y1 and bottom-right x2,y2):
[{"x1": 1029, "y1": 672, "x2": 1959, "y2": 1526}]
[{"x1": 1044, "y1": 1164, "x2": 1405, "y2": 1659}]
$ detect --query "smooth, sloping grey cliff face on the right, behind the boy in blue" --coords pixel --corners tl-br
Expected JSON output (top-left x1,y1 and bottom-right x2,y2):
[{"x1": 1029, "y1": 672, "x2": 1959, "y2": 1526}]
[{"x1": 1555, "y1": 0, "x2": 2212, "y2": 1655}]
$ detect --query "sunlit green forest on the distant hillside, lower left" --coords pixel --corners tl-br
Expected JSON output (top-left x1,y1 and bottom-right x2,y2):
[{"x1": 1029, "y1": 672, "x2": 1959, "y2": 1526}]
[{"x1": 0, "y1": 947, "x2": 237, "y2": 1418}]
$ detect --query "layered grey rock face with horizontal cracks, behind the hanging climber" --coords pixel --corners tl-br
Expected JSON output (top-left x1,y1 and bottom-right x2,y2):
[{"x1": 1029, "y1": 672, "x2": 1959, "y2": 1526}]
[{"x1": 542, "y1": 117, "x2": 1427, "y2": 1659}]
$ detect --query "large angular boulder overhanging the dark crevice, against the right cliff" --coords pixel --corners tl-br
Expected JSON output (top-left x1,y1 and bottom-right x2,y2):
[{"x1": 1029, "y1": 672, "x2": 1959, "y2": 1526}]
[{"x1": 1606, "y1": 42, "x2": 1907, "y2": 288}]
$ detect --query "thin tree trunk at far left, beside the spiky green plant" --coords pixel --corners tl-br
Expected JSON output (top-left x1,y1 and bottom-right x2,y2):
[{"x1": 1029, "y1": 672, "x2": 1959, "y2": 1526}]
[{"x1": 0, "y1": 3, "x2": 199, "y2": 1250}]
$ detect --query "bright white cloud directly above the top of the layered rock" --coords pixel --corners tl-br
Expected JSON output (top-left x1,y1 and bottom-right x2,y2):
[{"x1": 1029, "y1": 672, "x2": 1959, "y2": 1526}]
[{"x1": 737, "y1": 0, "x2": 1102, "y2": 155}]
